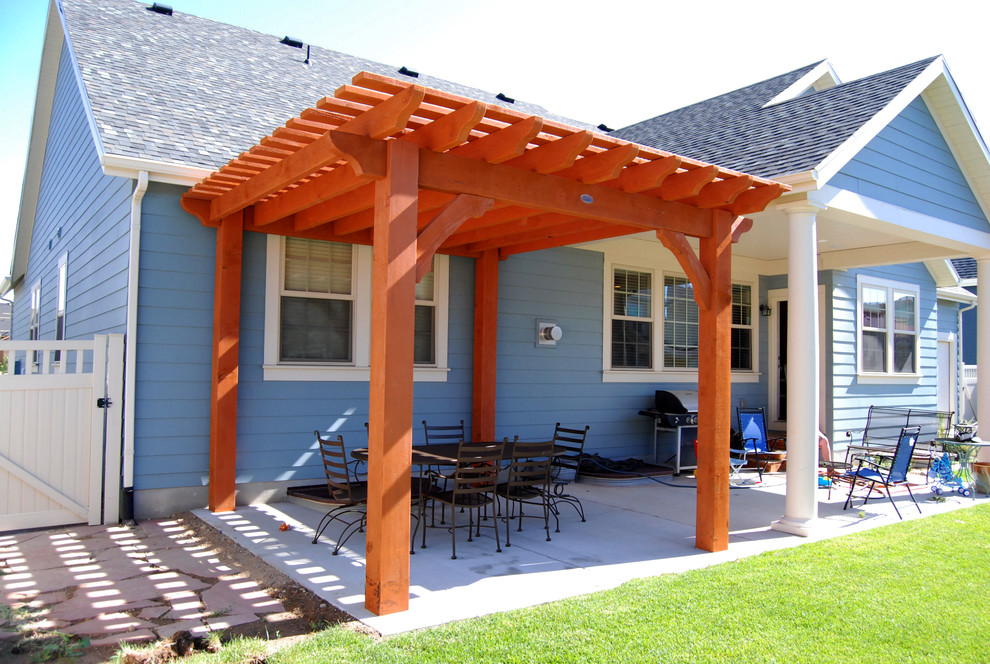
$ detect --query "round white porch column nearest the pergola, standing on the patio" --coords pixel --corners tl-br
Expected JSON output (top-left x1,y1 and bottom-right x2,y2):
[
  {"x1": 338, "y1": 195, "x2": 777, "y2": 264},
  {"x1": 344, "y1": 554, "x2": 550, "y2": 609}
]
[{"x1": 772, "y1": 202, "x2": 821, "y2": 537}]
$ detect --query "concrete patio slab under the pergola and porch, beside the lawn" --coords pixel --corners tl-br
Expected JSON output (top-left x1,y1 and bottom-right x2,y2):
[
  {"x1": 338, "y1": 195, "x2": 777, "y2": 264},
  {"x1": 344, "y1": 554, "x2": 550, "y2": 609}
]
[{"x1": 195, "y1": 474, "x2": 986, "y2": 634}]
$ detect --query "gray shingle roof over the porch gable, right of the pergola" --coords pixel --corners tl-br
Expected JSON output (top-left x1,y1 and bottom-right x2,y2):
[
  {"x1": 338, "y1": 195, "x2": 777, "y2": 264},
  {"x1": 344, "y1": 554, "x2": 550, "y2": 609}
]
[{"x1": 612, "y1": 58, "x2": 935, "y2": 177}]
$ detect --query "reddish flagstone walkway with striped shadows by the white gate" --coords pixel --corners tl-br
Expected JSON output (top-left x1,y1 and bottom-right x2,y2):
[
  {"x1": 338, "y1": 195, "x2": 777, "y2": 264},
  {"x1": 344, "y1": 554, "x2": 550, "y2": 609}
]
[{"x1": 0, "y1": 520, "x2": 295, "y2": 660}]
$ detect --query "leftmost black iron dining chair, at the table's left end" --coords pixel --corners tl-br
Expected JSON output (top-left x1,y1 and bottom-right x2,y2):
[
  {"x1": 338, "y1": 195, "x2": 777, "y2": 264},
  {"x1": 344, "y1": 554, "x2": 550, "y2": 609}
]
[{"x1": 313, "y1": 431, "x2": 368, "y2": 556}]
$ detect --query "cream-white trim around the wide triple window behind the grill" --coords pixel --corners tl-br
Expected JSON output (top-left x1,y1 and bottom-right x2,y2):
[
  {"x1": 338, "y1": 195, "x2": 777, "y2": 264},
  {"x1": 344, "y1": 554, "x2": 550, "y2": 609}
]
[{"x1": 602, "y1": 254, "x2": 761, "y2": 383}]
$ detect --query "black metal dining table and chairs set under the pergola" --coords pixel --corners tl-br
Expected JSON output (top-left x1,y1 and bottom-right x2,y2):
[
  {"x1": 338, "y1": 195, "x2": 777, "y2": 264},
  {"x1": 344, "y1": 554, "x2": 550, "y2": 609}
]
[{"x1": 313, "y1": 421, "x2": 590, "y2": 559}]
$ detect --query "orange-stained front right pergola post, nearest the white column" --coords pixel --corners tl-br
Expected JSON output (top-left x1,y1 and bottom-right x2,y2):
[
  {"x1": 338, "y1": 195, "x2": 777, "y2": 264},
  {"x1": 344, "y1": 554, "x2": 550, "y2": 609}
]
[{"x1": 694, "y1": 210, "x2": 735, "y2": 551}]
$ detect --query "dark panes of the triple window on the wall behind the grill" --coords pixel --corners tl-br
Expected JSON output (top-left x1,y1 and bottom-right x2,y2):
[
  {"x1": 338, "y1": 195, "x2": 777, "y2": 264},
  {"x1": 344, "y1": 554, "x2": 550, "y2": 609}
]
[{"x1": 605, "y1": 266, "x2": 756, "y2": 375}]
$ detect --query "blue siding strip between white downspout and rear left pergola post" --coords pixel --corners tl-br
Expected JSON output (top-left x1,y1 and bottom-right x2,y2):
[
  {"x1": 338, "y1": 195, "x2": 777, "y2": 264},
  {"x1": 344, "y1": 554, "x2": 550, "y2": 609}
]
[{"x1": 134, "y1": 183, "x2": 216, "y2": 490}]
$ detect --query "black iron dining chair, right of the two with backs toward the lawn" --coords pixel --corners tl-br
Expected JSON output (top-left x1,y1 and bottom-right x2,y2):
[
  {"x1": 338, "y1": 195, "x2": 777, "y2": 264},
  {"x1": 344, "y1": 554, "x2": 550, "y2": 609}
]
[{"x1": 495, "y1": 440, "x2": 553, "y2": 547}]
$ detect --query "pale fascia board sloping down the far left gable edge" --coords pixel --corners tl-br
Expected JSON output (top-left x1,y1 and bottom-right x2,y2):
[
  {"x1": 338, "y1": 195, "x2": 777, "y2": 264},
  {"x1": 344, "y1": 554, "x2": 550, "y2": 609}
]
[{"x1": 10, "y1": 0, "x2": 64, "y2": 283}]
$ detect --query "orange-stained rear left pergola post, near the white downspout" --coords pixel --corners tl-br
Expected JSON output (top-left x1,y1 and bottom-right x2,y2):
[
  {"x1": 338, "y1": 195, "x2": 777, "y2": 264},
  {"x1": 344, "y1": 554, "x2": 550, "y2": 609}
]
[{"x1": 209, "y1": 211, "x2": 244, "y2": 512}]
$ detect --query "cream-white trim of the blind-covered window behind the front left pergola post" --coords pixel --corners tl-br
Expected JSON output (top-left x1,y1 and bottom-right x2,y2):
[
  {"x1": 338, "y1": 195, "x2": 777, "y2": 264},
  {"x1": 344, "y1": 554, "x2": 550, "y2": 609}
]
[{"x1": 263, "y1": 235, "x2": 450, "y2": 382}]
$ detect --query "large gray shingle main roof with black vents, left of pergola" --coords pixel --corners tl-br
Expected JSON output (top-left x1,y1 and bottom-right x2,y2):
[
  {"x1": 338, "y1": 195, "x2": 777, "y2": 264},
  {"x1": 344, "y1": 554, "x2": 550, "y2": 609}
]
[{"x1": 61, "y1": 0, "x2": 590, "y2": 169}]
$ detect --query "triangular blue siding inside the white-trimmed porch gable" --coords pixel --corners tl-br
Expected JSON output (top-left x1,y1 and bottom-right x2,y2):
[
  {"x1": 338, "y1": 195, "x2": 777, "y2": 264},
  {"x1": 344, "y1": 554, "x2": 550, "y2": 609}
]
[{"x1": 829, "y1": 98, "x2": 990, "y2": 231}]
